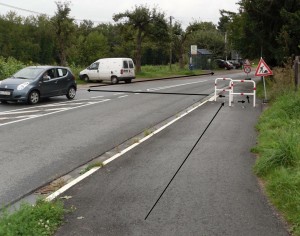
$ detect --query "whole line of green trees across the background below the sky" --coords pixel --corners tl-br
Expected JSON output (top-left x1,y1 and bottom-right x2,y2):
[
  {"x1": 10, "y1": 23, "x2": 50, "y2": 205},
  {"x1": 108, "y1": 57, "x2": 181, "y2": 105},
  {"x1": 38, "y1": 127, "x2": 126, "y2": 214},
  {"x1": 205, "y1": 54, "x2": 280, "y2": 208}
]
[{"x1": 0, "y1": 0, "x2": 300, "y2": 71}]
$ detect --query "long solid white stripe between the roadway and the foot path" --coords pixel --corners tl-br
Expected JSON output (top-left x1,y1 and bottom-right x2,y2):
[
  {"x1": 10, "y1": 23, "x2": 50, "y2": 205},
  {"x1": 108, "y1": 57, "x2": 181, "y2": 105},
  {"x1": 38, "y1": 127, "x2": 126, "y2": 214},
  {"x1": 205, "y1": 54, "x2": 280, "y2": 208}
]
[{"x1": 46, "y1": 97, "x2": 208, "y2": 201}]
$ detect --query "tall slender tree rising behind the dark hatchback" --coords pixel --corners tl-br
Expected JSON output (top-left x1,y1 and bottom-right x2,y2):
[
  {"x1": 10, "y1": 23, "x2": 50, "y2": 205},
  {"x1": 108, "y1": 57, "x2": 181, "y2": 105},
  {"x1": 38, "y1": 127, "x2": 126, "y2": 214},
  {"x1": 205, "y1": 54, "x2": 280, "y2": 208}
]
[{"x1": 51, "y1": 2, "x2": 75, "y2": 66}]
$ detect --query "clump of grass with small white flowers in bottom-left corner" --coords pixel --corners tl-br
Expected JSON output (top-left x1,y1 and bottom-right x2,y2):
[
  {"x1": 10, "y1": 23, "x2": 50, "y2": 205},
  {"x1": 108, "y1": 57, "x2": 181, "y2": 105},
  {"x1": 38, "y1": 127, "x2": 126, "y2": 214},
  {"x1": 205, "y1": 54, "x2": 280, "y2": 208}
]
[{"x1": 0, "y1": 199, "x2": 65, "y2": 236}]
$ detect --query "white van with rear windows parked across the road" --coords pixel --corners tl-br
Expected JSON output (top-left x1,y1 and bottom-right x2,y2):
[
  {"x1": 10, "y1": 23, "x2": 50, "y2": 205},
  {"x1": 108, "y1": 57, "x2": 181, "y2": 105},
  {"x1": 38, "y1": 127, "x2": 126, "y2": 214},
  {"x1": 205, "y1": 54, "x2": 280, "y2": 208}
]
[{"x1": 79, "y1": 58, "x2": 135, "y2": 84}]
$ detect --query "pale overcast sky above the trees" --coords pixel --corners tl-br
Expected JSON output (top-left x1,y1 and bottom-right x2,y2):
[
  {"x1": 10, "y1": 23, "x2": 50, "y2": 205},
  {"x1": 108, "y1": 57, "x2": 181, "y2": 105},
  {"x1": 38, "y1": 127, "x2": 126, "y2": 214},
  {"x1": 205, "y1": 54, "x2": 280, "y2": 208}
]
[{"x1": 0, "y1": 0, "x2": 238, "y2": 28}]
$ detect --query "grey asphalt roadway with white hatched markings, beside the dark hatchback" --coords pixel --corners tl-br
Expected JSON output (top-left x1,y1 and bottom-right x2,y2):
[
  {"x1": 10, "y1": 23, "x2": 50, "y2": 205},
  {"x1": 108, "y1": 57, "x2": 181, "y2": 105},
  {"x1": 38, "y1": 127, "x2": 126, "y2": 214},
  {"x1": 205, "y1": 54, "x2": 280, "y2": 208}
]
[{"x1": 0, "y1": 72, "x2": 245, "y2": 205}]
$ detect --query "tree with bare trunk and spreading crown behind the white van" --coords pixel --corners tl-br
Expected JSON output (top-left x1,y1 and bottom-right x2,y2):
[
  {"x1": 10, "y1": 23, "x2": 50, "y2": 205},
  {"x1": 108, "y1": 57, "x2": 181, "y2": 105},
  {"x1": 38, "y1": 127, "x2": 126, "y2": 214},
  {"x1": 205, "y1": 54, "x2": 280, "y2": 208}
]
[{"x1": 113, "y1": 6, "x2": 168, "y2": 72}]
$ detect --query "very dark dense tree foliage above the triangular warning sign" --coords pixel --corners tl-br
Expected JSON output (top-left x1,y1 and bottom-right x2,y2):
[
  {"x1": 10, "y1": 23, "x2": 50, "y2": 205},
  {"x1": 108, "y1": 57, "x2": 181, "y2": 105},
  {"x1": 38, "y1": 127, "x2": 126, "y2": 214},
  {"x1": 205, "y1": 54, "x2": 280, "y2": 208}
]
[{"x1": 219, "y1": 0, "x2": 300, "y2": 66}]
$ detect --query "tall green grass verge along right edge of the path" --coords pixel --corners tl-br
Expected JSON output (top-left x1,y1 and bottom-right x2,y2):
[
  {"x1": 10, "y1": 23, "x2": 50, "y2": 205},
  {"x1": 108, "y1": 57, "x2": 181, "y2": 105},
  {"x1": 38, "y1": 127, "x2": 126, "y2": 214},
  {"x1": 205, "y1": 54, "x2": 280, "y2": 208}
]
[{"x1": 252, "y1": 62, "x2": 300, "y2": 236}]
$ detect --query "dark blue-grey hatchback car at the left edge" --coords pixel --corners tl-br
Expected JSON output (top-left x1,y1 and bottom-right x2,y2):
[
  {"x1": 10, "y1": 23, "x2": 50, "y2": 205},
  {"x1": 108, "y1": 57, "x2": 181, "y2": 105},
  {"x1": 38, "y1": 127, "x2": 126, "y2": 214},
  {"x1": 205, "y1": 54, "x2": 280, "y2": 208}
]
[{"x1": 0, "y1": 66, "x2": 77, "y2": 104}]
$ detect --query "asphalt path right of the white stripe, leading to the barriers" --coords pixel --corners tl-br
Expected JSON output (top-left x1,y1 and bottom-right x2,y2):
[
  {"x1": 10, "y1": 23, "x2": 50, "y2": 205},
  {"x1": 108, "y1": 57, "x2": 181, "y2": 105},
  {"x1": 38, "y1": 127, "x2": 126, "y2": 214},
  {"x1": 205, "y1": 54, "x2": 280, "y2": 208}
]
[{"x1": 56, "y1": 98, "x2": 289, "y2": 236}]
